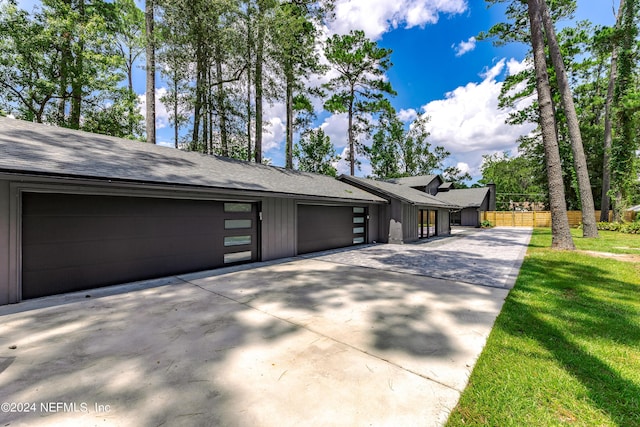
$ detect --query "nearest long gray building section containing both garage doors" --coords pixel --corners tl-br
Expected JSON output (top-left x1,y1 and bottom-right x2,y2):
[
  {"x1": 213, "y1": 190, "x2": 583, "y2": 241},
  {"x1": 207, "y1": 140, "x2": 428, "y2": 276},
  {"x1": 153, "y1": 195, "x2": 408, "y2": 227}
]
[{"x1": 0, "y1": 118, "x2": 390, "y2": 304}]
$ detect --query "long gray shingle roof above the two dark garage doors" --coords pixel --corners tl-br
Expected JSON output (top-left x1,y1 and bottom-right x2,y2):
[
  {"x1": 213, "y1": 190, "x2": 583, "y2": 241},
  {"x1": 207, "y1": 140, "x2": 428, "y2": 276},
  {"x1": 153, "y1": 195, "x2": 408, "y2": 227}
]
[{"x1": 0, "y1": 117, "x2": 385, "y2": 202}]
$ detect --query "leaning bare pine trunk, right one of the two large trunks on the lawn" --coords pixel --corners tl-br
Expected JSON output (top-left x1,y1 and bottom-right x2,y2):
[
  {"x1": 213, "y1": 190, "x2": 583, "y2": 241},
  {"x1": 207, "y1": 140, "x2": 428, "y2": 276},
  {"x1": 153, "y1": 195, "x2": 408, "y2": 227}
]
[{"x1": 539, "y1": 0, "x2": 598, "y2": 237}]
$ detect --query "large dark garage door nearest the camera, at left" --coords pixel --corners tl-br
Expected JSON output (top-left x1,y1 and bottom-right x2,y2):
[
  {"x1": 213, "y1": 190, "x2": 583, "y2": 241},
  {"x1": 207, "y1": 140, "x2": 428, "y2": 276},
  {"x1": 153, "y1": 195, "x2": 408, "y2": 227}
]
[{"x1": 22, "y1": 193, "x2": 259, "y2": 299}]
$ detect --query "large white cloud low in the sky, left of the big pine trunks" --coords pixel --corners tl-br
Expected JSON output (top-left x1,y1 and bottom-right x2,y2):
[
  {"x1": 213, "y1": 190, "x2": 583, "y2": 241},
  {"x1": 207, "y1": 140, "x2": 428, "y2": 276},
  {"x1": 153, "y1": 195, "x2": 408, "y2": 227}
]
[{"x1": 422, "y1": 59, "x2": 536, "y2": 176}]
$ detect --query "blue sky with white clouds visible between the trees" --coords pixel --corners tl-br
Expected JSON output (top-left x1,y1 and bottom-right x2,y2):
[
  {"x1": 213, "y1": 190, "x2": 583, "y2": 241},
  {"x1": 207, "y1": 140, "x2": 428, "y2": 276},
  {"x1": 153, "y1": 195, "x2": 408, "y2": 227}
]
[{"x1": 13, "y1": 0, "x2": 619, "y2": 180}]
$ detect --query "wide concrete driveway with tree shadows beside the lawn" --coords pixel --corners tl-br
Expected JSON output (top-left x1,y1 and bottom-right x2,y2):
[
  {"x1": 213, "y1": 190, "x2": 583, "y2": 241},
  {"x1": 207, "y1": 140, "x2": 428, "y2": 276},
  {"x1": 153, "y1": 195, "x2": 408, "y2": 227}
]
[{"x1": 0, "y1": 228, "x2": 531, "y2": 426}]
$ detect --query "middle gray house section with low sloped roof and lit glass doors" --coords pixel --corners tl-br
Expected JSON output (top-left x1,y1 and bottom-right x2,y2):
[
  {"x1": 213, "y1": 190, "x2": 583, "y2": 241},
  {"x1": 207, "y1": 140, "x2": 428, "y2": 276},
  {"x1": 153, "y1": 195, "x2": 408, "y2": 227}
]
[{"x1": 339, "y1": 175, "x2": 459, "y2": 243}]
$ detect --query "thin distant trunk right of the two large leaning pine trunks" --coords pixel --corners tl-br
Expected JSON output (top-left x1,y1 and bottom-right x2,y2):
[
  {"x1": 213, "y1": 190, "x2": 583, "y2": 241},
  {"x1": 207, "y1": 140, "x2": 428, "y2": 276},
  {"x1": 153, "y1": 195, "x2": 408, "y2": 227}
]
[{"x1": 600, "y1": 0, "x2": 624, "y2": 222}]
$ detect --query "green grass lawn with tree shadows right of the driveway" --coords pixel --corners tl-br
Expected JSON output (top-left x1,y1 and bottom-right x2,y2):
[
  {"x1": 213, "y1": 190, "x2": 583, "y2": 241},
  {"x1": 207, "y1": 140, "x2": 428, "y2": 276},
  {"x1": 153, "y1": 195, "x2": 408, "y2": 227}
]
[{"x1": 447, "y1": 229, "x2": 640, "y2": 427}]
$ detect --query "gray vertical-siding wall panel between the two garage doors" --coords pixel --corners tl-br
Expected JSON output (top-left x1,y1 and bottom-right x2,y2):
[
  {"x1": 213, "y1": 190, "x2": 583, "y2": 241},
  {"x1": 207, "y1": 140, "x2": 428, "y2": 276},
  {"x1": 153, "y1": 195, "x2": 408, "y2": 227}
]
[{"x1": 262, "y1": 198, "x2": 297, "y2": 261}]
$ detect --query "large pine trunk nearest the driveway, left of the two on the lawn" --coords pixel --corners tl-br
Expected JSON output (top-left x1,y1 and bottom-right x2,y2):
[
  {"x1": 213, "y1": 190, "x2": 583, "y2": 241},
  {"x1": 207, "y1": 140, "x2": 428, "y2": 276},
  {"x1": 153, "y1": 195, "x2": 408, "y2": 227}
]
[{"x1": 527, "y1": 0, "x2": 575, "y2": 250}]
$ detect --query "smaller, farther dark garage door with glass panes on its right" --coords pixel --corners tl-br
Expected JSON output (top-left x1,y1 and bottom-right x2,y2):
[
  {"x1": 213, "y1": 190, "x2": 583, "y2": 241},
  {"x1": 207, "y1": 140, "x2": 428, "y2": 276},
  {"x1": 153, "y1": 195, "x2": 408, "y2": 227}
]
[{"x1": 298, "y1": 205, "x2": 367, "y2": 254}]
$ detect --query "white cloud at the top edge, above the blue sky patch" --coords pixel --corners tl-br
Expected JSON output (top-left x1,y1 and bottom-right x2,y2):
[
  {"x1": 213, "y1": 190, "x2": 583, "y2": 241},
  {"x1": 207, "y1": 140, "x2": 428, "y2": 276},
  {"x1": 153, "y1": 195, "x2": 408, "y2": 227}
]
[{"x1": 329, "y1": 0, "x2": 468, "y2": 40}]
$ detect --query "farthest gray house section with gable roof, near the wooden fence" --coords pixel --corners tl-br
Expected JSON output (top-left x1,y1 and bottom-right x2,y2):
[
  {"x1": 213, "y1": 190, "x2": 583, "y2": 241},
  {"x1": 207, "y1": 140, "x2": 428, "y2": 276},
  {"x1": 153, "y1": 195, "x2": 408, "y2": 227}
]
[{"x1": 436, "y1": 184, "x2": 496, "y2": 227}]
